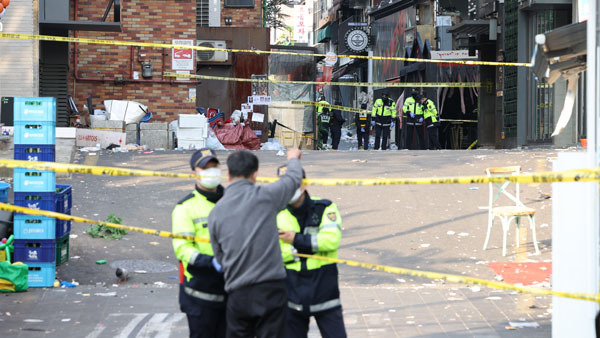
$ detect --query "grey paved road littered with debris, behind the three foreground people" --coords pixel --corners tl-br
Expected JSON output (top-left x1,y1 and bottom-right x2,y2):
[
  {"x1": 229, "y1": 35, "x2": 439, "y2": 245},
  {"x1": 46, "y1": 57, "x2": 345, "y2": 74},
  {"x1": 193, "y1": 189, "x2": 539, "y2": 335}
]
[{"x1": 0, "y1": 150, "x2": 556, "y2": 337}]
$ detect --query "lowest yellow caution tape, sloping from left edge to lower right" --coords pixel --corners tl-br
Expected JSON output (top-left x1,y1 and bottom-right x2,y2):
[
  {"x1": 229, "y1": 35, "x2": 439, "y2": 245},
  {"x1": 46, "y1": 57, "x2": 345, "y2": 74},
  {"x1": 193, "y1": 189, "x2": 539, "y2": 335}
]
[{"x1": 0, "y1": 203, "x2": 600, "y2": 302}]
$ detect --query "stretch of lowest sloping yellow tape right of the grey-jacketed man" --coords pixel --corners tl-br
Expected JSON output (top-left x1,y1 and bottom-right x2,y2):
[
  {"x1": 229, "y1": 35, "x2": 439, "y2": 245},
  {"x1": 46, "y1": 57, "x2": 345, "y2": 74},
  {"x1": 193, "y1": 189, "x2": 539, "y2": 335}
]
[{"x1": 295, "y1": 253, "x2": 600, "y2": 303}]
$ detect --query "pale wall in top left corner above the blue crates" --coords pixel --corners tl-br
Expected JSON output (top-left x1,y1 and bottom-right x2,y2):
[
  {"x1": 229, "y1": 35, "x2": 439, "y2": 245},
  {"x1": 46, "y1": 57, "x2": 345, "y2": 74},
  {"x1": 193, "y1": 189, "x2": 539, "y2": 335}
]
[{"x1": 0, "y1": 0, "x2": 39, "y2": 102}]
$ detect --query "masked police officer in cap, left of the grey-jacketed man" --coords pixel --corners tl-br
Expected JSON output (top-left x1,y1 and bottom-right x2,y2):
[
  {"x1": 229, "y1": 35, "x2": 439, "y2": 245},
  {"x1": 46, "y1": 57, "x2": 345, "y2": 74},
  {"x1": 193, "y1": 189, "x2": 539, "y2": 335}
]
[{"x1": 172, "y1": 148, "x2": 226, "y2": 338}]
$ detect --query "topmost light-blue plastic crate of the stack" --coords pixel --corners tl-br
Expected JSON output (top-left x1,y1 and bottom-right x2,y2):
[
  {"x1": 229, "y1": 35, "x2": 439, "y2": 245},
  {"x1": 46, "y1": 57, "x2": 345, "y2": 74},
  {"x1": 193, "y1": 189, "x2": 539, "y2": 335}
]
[{"x1": 13, "y1": 97, "x2": 56, "y2": 122}]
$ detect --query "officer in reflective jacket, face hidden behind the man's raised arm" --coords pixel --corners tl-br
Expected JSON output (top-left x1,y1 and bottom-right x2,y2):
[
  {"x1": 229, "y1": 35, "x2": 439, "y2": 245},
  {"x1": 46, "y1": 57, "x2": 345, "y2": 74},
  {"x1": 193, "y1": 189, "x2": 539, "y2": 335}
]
[{"x1": 277, "y1": 166, "x2": 346, "y2": 338}]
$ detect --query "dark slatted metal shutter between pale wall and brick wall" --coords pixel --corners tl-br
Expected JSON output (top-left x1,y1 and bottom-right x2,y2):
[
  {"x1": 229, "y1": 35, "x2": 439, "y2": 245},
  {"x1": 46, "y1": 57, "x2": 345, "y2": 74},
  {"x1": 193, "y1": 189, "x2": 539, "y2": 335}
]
[{"x1": 40, "y1": 64, "x2": 69, "y2": 127}]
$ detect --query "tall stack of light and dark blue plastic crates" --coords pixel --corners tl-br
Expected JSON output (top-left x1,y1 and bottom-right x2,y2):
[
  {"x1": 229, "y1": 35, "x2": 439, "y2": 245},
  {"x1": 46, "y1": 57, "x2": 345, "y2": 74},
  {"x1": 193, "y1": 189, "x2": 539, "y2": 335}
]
[{"x1": 13, "y1": 97, "x2": 72, "y2": 287}]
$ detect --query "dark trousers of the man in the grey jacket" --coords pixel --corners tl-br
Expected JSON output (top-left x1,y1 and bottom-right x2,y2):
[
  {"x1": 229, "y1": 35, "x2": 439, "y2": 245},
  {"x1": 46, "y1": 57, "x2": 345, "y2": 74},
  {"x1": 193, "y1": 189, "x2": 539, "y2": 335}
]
[{"x1": 227, "y1": 281, "x2": 287, "y2": 338}]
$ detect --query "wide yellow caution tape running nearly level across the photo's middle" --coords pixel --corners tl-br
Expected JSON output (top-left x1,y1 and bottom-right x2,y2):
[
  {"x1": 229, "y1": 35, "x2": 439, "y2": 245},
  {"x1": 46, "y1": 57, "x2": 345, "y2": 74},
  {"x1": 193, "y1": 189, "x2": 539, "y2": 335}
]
[{"x1": 0, "y1": 160, "x2": 600, "y2": 186}]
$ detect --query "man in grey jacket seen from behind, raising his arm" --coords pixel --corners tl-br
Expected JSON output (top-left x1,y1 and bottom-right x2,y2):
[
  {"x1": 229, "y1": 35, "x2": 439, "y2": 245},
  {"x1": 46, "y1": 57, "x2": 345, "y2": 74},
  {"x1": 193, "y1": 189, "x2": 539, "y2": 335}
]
[{"x1": 208, "y1": 149, "x2": 302, "y2": 338}]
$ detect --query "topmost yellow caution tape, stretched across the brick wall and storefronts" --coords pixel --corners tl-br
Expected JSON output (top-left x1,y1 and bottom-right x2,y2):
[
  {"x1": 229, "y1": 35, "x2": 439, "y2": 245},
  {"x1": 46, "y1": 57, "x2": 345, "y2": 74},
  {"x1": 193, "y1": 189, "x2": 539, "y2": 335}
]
[{"x1": 0, "y1": 32, "x2": 532, "y2": 67}]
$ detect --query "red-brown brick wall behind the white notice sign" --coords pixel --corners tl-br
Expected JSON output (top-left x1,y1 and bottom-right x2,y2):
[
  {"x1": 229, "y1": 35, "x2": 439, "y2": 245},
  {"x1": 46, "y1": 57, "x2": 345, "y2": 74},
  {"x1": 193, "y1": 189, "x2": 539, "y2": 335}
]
[{"x1": 69, "y1": 0, "x2": 196, "y2": 121}]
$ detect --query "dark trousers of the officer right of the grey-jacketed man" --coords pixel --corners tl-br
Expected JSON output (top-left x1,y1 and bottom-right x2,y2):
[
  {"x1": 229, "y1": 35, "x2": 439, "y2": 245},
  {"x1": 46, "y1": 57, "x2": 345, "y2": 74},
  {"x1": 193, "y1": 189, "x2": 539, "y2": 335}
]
[{"x1": 285, "y1": 307, "x2": 346, "y2": 338}]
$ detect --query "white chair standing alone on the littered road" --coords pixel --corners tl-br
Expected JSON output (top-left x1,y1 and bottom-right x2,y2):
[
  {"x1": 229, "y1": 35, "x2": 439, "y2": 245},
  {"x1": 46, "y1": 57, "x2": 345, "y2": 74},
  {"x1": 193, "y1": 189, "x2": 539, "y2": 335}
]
[{"x1": 483, "y1": 166, "x2": 540, "y2": 256}]
